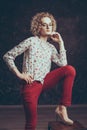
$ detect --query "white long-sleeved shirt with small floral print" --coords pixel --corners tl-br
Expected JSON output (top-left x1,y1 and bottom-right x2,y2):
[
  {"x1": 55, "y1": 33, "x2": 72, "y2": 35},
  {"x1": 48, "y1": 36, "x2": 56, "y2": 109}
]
[{"x1": 3, "y1": 36, "x2": 67, "y2": 83}]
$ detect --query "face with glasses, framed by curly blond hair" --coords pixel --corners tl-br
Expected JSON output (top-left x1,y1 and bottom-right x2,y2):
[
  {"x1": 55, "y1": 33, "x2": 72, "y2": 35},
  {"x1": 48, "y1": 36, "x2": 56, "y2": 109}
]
[{"x1": 40, "y1": 17, "x2": 52, "y2": 37}]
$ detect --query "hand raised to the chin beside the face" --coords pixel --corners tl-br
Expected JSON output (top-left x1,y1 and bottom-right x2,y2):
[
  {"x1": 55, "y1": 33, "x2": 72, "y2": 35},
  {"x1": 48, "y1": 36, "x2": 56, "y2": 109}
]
[{"x1": 50, "y1": 32, "x2": 63, "y2": 43}]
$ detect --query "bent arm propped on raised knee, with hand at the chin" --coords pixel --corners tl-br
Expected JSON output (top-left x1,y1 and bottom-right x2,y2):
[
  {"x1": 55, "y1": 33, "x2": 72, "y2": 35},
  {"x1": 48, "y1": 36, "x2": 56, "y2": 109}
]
[{"x1": 51, "y1": 33, "x2": 67, "y2": 66}]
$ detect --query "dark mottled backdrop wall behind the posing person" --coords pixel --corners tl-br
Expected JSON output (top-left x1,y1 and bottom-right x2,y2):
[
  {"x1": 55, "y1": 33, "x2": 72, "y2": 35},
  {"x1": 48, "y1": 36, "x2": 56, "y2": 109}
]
[{"x1": 0, "y1": 0, "x2": 87, "y2": 105}]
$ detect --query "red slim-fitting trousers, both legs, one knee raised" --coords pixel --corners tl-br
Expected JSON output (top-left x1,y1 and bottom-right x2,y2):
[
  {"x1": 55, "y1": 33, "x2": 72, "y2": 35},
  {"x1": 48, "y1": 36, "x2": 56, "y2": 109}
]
[{"x1": 22, "y1": 65, "x2": 76, "y2": 130}]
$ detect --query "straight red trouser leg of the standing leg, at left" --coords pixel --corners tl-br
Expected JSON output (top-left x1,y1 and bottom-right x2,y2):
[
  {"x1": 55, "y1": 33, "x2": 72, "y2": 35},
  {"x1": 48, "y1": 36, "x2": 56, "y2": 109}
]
[{"x1": 22, "y1": 82, "x2": 42, "y2": 130}]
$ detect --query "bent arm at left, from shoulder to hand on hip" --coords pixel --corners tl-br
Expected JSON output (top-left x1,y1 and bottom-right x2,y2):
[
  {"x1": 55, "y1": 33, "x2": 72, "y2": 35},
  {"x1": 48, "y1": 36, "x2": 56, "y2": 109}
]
[{"x1": 3, "y1": 38, "x2": 31, "y2": 82}]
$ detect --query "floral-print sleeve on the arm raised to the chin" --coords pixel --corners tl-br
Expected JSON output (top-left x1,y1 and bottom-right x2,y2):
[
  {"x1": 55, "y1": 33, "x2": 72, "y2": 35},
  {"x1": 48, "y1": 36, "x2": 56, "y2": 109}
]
[{"x1": 52, "y1": 43, "x2": 67, "y2": 66}]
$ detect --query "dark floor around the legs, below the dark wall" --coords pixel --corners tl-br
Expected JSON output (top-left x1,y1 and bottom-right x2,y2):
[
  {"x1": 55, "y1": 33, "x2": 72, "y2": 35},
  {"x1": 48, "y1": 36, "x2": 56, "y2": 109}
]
[{"x1": 0, "y1": 105, "x2": 87, "y2": 130}]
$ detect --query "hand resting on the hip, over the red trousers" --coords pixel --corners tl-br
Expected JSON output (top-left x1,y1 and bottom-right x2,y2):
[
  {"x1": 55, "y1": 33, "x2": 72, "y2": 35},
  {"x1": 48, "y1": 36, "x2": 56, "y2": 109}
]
[{"x1": 19, "y1": 73, "x2": 34, "y2": 84}]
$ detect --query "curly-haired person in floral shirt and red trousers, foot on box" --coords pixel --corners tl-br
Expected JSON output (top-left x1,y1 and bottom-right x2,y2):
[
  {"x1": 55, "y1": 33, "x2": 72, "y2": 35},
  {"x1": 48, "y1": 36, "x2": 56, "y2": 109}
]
[{"x1": 3, "y1": 12, "x2": 76, "y2": 130}]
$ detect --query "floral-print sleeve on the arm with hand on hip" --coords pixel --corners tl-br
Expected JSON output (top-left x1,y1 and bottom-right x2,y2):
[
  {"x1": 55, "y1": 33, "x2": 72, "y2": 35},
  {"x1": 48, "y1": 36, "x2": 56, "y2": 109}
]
[{"x1": 3, "y1": 38, "x2": 31, "y2": 70}]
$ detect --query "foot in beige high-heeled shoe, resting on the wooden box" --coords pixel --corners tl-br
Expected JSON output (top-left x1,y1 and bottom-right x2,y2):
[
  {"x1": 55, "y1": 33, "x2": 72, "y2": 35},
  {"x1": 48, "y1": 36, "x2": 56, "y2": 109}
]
[{"x1": 55, "y1": 105, "x2": 74, "y2": 125}]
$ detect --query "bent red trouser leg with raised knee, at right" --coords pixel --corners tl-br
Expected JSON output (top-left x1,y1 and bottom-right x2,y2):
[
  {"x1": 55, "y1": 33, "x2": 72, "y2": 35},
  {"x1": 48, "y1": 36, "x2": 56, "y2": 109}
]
[{"x1": 43, "y1": 65, "x2": 76, "y2": 106}]
